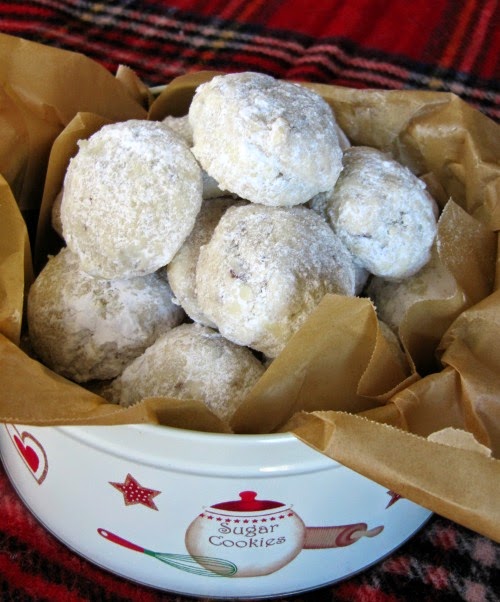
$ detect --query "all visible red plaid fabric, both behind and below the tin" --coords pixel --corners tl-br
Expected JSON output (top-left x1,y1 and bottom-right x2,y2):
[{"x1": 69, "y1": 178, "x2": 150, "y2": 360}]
[{"x1": 0, "y1": 0, "x2": 500, "y2": 602}]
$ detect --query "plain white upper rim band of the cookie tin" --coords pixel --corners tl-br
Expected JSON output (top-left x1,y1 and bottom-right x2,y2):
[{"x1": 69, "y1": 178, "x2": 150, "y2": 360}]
[{"x1": 54, "y1": 424, "x2": 343, "y2": 477}]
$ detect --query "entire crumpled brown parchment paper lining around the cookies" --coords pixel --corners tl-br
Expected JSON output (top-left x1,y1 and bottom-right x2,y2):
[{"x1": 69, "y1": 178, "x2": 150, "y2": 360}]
[{"x1": 0, "y1": 36, "x2": 500, "y2": 541}]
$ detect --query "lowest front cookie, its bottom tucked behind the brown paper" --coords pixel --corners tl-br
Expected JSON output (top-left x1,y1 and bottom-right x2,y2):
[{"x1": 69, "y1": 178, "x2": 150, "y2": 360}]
[{"x1": 116, "y1": 323, "x2": 264, "y2": 421}]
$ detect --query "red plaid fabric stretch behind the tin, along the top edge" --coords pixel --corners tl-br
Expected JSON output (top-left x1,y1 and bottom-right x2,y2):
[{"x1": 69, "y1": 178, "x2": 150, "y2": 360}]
[{"x1": 0, "y1": 0, "x2": 500, "y2": 119}]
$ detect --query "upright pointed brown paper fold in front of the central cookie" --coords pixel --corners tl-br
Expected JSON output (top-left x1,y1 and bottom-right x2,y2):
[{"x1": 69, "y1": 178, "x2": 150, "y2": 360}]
[{"x1": 232, "y1": 295, "x2": 418, "y2": 433}]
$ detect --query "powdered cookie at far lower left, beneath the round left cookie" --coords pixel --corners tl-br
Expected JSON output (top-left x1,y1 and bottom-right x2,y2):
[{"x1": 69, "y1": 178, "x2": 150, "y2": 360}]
[{"x1": 28, "y1": 247, "x2": 184, "y2": 382}]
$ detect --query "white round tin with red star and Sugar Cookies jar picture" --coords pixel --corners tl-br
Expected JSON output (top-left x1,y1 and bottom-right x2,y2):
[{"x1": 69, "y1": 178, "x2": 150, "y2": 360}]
[{"x1": 0, "y1": 424, "x2": 431, "y2": 598}]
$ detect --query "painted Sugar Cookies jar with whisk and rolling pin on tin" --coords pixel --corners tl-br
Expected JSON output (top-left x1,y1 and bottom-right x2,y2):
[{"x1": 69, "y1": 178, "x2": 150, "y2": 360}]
[{"x1": 97, "y1": 491, "x2": 384, "y2": 577}]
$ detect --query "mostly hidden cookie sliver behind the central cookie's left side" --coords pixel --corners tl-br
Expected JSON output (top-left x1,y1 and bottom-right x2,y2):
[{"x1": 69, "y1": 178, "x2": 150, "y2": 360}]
[{"x1": 166, "y1": 197, "x2": 245, "y2": 328}]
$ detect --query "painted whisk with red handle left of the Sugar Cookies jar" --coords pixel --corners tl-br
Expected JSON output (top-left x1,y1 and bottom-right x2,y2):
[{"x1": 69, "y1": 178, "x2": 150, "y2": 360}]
[{"x1": 97, "y1": 528, "x2": 238, "y2": 577}]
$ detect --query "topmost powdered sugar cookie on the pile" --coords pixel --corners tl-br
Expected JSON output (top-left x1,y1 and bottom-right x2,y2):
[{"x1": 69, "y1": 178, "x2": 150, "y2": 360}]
[{"x1": 189, "y1": 72, "x2": 342, "y2": 206}]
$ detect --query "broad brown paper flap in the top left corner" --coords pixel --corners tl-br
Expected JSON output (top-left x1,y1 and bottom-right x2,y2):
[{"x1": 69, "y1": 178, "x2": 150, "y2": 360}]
[{"x1": 0, "y1": 34, "x2": 146, "y2": 210}]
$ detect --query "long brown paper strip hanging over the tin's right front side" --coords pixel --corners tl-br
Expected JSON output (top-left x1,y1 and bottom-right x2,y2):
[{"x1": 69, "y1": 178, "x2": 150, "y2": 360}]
[{"x1": 287, "y1": 412, "x2": 500, "y2": 541}]
